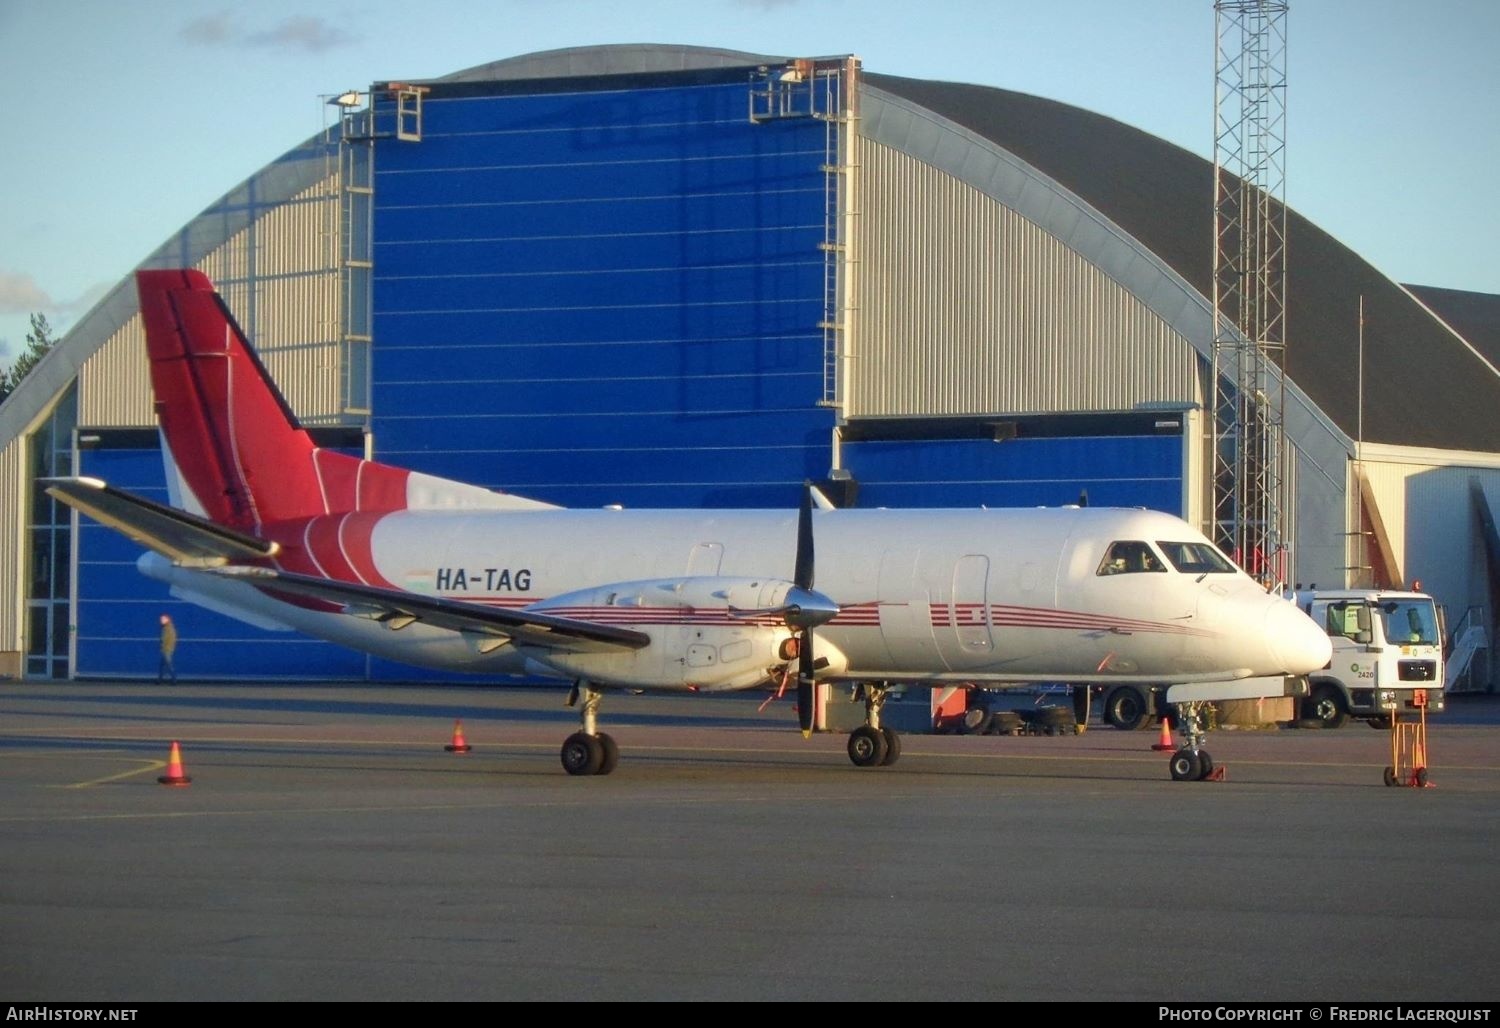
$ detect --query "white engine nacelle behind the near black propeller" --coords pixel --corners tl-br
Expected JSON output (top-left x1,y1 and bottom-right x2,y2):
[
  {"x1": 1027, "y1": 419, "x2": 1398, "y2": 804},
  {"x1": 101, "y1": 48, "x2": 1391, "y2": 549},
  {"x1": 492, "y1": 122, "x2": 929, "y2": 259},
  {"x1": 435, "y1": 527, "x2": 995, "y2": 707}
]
[{"x1": 521, "y1": 576, "x2": 824, "y2": 692}]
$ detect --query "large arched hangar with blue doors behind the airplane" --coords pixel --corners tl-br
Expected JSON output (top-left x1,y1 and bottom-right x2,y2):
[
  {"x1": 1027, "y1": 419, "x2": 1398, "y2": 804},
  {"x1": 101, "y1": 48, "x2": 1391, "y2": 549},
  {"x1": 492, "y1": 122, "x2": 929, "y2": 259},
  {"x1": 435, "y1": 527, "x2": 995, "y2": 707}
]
[{"x1": 0, "y1": 45, "x2": 1500, "y2": 680}]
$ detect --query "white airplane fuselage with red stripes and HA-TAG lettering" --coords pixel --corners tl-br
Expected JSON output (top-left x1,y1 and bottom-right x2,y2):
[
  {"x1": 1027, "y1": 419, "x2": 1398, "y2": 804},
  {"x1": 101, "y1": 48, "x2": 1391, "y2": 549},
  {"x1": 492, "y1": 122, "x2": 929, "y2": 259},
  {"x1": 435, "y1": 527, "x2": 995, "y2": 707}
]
[{"x1": 147, "y1": 507, "x2": 1328, "y2": 687}]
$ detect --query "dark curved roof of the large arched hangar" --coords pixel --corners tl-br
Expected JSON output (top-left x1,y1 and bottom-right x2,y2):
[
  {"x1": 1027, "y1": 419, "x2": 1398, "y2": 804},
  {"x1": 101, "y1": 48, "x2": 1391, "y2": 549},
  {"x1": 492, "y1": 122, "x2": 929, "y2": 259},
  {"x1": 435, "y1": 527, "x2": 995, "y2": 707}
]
[{"x1": 443, "y1": 44, "x2": 1500, "y2": 452}]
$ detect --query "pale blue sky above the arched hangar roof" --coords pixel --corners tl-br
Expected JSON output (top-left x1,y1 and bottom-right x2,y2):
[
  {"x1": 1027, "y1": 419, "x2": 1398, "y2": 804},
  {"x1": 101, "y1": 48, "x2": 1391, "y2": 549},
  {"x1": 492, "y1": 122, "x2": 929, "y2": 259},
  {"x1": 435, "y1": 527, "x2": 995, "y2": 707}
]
[{"x1": 0, "y1": 0, "x2": 1500, "y2": 360}]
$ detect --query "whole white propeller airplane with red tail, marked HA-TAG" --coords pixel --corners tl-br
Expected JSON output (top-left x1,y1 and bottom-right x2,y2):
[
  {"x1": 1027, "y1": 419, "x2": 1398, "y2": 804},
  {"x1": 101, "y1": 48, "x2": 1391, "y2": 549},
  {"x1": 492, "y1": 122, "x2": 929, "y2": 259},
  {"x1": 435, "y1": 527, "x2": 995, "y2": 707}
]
[{"x1": 42, "y1": 270, "x2": 1331, "y2": 777}]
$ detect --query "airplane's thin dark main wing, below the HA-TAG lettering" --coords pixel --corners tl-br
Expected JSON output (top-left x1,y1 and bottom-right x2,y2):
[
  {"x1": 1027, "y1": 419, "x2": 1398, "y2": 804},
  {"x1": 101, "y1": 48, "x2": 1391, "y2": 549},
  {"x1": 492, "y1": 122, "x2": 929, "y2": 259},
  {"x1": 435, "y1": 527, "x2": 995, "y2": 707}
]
[{"x1": 210, "y1": 567, "x2": 651, "y2": 651}]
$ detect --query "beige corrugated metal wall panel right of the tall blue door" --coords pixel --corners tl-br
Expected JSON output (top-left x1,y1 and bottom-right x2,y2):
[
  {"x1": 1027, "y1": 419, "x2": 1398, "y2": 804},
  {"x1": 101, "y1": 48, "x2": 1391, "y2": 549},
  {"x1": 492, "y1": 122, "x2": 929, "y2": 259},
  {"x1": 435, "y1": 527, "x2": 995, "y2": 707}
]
[{"x1": 845, "y1": 140, "x2": 1197, "y2": 417}]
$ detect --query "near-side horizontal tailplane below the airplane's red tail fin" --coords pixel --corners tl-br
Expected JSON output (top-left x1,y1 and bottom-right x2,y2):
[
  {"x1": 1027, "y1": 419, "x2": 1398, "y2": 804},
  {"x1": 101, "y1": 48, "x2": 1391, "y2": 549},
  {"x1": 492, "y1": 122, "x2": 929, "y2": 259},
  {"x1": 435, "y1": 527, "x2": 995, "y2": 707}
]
[{"x1": 38, "y1": 477, "x2": 278, "y2": 567}]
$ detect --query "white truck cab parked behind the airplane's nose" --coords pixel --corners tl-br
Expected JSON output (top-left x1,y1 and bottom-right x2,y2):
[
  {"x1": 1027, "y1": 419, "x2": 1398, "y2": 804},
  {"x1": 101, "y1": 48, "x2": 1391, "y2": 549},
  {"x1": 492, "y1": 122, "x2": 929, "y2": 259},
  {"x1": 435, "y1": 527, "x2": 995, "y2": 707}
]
[{"x1": 1293, "y1": 590, "x2": 1443, "y2": 728}]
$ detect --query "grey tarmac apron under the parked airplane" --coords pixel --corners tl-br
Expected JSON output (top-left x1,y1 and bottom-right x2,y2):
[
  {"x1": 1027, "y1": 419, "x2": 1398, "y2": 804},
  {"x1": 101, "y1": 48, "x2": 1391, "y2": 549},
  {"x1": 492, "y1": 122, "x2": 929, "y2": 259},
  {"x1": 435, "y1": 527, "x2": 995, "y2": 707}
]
[{"x1": 0, "y1": 681, "x2": 1500, "y2": 1004}]
